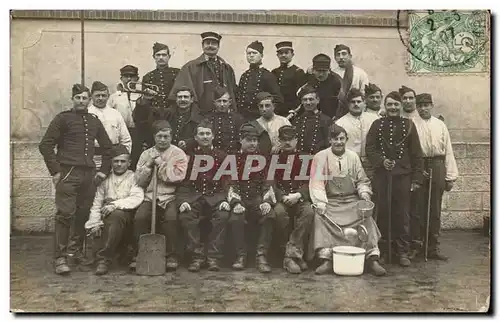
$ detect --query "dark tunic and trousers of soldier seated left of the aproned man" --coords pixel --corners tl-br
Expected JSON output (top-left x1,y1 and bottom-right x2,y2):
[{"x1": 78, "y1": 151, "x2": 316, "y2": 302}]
[{"x1": 273, "y1": 150, "x2": 314, "y2": 259}]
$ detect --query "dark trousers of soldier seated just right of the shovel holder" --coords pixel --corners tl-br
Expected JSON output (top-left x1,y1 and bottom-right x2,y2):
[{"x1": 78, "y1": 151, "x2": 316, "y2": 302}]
[{"x1": 179, "y1": 198, "x2": 229, "y2": 260}]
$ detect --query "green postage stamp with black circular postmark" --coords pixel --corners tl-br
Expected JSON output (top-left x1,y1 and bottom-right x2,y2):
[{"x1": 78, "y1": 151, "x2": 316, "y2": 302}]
[{"x1": 398, "y1": 10, "x2": 490, "y2": 75}]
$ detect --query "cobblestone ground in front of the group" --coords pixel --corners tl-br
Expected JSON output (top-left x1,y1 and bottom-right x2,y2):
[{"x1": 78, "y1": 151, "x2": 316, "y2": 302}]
[{"x1": 11, "y1": 231, "x2": 490, "y2": 312}]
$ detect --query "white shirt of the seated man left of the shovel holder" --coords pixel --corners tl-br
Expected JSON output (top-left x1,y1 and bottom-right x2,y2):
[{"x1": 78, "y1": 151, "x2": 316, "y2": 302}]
[{"x1": 85, "y1": 170, "x2": 144, "y2": 229}]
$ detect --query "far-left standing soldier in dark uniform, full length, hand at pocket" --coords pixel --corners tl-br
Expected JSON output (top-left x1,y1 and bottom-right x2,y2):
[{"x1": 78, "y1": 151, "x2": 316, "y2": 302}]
[{"x1": 39, "y1": 84, "x2": 112, "y2": 274}]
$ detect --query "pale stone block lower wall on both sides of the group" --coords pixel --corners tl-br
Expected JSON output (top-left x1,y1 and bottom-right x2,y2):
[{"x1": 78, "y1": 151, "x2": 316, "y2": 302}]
[{"x1": 11, "y1": 142, "x2": 490, "y2": 232}]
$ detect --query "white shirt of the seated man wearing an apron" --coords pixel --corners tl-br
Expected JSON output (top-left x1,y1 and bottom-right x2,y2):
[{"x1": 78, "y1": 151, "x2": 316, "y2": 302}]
[{"x1": 309, "y1": 147, "x2": 372, "y2": 204}]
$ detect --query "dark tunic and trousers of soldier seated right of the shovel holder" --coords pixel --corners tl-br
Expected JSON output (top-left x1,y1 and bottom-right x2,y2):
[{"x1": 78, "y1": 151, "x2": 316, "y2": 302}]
[{"x1": 176, "y1": 147, "x2": 229, "y2": 260}]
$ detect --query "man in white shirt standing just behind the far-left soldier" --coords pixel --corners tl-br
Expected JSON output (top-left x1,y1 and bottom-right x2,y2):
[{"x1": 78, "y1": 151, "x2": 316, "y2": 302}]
[{"x1": 88, "y1": 81, "x2": 132, "y2": 170}]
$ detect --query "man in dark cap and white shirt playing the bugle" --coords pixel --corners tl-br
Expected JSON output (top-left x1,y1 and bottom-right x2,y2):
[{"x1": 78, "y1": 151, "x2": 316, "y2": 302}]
[{"x1": 108, "y1": 65, "x2": 146, "y2": 171}]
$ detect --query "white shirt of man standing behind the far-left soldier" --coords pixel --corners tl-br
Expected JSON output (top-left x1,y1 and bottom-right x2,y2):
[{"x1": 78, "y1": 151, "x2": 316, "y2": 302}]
[{"x1": 88, "y1": 104, "x2": 132, "y2": 152}]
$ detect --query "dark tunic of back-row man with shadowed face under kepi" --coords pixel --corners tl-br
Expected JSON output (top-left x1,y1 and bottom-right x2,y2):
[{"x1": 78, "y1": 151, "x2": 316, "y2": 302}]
[{"x1": 305, "y1": 73, "x2": 347, "y2": 118}]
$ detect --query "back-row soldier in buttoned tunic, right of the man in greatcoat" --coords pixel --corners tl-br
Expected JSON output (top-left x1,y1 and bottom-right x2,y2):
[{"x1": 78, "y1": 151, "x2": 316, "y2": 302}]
[{"x1": 236, "y1": 41, "x2": 283, "y2": 121}]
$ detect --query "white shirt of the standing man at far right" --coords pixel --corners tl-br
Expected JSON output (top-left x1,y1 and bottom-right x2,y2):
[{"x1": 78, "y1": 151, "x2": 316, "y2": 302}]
[{"x1": 413, "y1": 116, "x2": 458, "y2": 181}]
